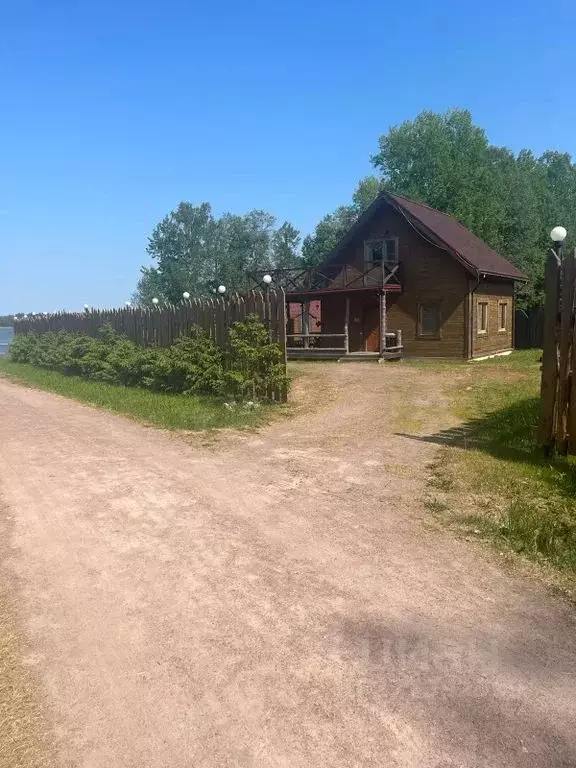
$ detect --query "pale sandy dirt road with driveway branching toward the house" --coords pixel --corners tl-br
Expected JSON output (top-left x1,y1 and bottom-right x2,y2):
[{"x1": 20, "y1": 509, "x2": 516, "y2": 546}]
[{"x1": 0, "y1": 364, "x2": 576, "y2": 768}]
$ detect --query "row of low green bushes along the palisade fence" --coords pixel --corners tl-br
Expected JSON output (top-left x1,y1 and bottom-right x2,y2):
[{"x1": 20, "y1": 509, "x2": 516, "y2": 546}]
[{"x1": 10, "y1": 315, "x2": 288, "y2": 399}]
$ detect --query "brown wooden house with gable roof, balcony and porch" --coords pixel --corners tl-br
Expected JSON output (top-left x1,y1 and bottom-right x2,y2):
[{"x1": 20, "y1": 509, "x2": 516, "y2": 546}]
[{"x1": 262, "y1": 192, "x2": 525, "y2": 359}]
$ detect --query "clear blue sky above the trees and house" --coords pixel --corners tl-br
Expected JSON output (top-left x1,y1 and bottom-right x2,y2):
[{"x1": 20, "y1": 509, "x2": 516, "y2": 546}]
[{"x1": 0, "y1": 0, "x2": 576, "y2": 313}]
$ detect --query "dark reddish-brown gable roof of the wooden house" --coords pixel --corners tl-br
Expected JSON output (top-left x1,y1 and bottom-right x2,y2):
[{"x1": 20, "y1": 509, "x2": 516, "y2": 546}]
[{"x1": 330, "y1": 192, "x2": 526, "y2": 281}]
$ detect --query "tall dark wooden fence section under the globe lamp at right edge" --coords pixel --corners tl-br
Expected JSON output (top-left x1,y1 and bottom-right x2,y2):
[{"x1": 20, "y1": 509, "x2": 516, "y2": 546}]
[{"x1": 539, "y1": 250, "x2": 576, "y2": 455}]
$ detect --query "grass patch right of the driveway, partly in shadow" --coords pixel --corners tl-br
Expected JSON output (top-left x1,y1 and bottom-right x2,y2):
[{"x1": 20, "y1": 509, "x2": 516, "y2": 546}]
[{"x1": 420, "y1": 350, "x2": 576, "y2": 574}]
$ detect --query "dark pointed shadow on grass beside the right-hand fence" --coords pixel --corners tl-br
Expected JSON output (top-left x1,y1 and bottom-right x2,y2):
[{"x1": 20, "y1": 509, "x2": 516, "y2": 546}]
[{"x1": 396, "y1": 397, "x2": 576, "y2": 498}]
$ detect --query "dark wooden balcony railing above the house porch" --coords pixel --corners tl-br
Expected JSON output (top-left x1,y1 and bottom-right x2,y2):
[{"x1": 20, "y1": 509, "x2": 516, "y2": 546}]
[{"x1": 251, "y1": 262, "x2": 402, "y2": 295}]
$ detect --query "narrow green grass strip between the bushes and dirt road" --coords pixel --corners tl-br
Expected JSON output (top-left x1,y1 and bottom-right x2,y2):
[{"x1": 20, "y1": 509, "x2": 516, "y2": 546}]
[{"x1": 0, "y1": 358, "x2": 271, "y2": 430}]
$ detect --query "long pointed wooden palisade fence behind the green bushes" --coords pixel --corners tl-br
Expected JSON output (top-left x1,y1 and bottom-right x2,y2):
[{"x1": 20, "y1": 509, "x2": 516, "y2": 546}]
[{"x1": 14, "y1": 288, "x2": 286, "y2": 400}]
